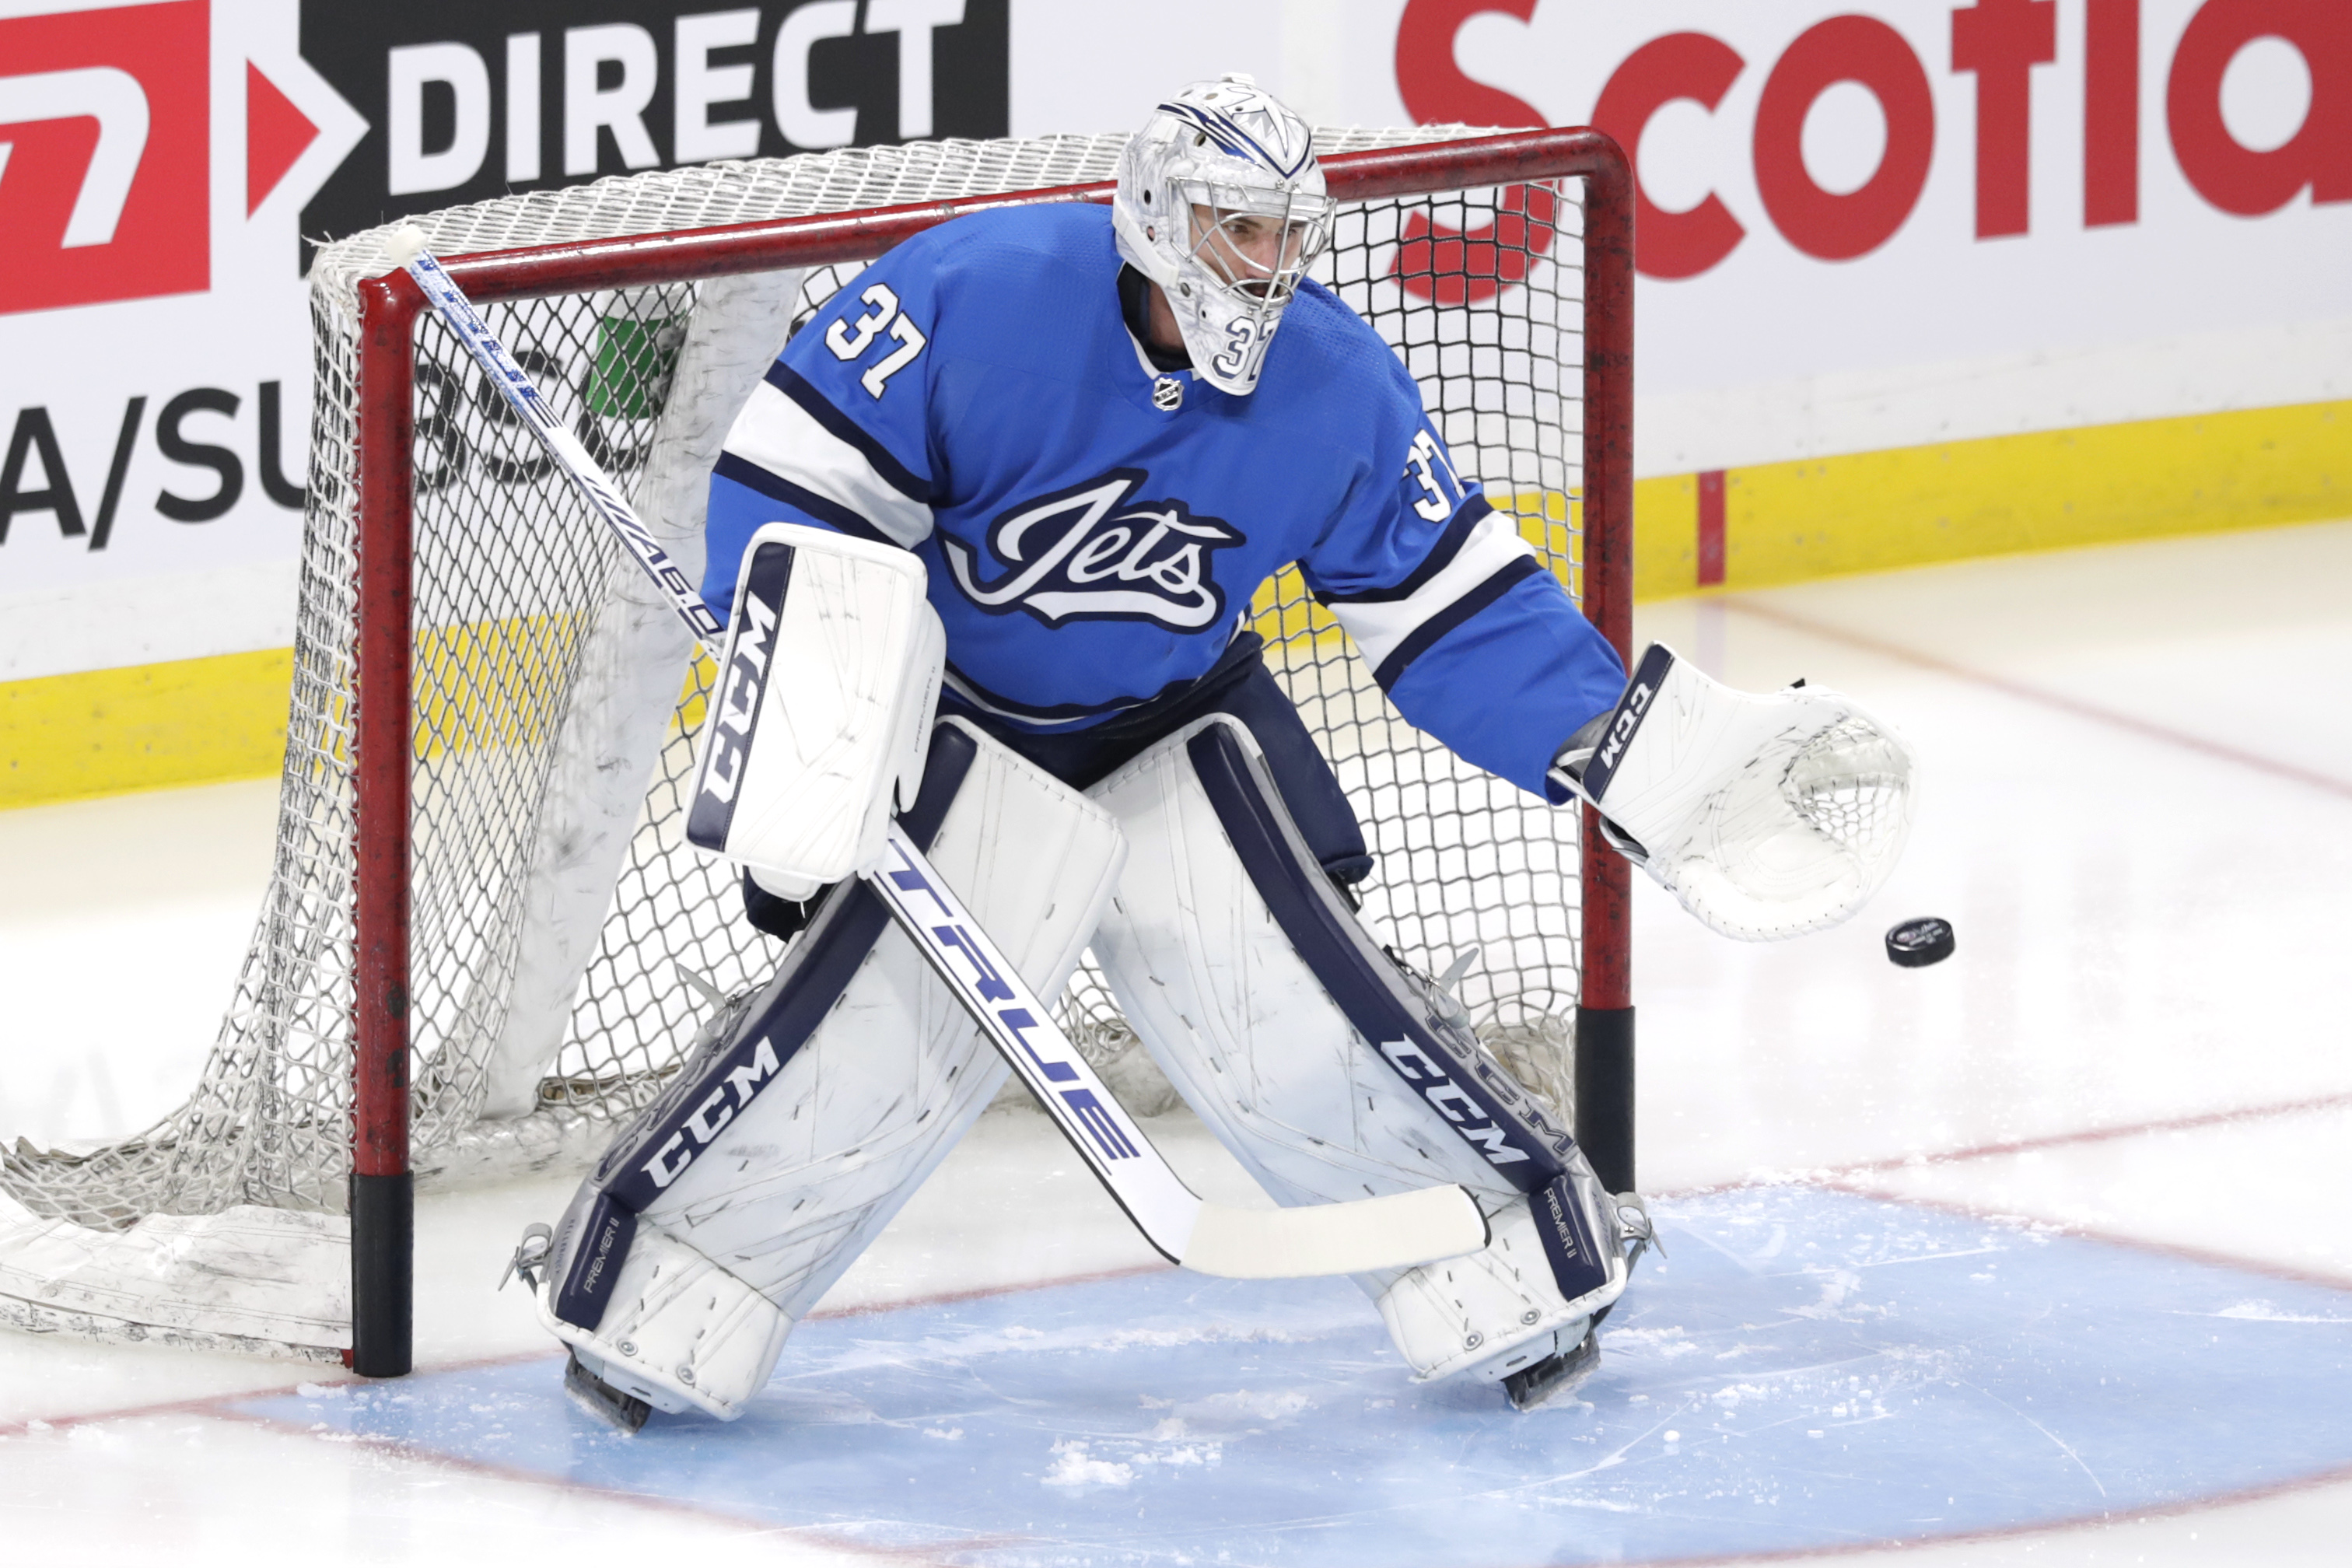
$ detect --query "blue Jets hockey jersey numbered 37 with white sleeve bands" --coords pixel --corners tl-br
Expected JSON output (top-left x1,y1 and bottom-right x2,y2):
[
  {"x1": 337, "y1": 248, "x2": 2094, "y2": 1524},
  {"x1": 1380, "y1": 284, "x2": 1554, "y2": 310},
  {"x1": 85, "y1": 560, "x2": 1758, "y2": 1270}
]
[{"x1": 703, "y1": 205, "x2": 1626, "y2": 800}]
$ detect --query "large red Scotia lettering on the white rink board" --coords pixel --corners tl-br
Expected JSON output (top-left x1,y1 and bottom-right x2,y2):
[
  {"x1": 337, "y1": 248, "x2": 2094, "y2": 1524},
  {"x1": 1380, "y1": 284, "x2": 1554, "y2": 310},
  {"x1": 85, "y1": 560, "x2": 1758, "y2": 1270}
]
[{"x1": 1395, "y1": 0, "x2": 2352, "y2": 281}]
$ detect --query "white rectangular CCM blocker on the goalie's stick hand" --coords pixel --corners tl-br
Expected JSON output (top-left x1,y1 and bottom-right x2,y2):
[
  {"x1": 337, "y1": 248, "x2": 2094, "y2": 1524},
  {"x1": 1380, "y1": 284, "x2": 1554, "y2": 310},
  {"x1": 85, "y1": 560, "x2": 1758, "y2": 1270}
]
[{"x1": 687, "y1": 522, "x2": 948, "y2": 898}]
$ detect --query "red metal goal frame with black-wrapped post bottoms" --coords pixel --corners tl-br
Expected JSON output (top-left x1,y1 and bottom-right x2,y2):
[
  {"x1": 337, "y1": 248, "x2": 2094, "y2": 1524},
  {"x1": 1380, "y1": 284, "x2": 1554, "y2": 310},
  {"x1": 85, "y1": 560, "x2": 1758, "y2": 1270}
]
[{"x1": 351, "y1": 129, "x2": 1635, "y2": 1375}]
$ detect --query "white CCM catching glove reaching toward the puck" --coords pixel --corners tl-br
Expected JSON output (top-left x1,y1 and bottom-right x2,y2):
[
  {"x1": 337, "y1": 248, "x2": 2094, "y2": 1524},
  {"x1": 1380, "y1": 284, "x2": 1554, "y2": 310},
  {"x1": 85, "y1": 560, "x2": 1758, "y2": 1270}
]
[{"x1": 1552, "y1": 642, "x2": 1917, "y2": 943}]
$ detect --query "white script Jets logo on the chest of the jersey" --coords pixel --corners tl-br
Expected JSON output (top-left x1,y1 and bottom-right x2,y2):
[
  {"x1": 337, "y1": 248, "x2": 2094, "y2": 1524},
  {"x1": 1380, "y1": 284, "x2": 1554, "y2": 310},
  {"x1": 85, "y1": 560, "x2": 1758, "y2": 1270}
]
[{"x1": 941, "y1": 467, "x2": 1242, "y2": 632}]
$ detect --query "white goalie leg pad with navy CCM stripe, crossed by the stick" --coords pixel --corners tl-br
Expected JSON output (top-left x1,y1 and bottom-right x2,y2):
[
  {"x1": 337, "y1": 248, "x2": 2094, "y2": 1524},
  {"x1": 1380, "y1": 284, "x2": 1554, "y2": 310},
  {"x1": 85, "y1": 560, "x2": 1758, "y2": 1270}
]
[{"x1": 544, "y1": 719, "x2": 1124, "y2": 1416}]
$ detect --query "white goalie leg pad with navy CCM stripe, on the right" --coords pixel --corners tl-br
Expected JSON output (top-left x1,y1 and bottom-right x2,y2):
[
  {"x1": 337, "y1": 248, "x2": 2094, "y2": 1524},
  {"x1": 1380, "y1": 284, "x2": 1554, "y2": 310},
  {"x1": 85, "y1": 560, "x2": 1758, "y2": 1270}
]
[{"x1": 1094, "y1": 715, "x2": 1626, "y2": 1375}]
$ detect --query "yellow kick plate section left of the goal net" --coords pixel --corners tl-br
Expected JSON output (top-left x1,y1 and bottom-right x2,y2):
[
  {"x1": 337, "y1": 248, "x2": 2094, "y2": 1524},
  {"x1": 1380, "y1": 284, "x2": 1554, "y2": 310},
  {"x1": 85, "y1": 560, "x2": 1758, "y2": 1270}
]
[{"x1": 0, "y1": 649, "x2": 294, "y2": 807}]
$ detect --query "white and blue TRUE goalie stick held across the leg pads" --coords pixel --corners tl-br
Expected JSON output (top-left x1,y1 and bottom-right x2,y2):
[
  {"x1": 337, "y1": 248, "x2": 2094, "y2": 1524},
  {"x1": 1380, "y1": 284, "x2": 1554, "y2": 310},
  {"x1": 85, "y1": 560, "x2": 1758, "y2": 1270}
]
[{"x1": 386, "y1": 226, "x2": 1489, "y2": 1279}]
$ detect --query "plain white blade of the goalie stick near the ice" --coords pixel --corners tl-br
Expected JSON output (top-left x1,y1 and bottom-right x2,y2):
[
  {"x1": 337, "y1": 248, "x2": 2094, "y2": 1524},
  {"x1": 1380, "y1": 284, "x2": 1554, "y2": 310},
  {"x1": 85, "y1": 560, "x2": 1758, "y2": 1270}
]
[{"x1": 1183, "y1": 1187, "x2": 1489, "y2": 1279}]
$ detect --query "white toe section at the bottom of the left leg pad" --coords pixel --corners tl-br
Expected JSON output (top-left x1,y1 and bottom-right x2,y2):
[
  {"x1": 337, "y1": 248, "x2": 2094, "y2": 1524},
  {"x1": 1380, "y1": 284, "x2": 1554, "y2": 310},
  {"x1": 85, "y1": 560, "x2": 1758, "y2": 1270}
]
[{"x1": 536, "y1": 1227, "x2": 793, "y2": 1420}]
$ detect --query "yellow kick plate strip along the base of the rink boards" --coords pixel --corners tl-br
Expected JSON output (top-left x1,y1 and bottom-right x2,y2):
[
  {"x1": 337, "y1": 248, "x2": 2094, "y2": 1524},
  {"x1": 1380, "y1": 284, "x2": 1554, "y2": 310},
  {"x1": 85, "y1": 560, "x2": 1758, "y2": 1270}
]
[{"x1": 0, "y1": 402, "x2": 2352, "y2": 807}]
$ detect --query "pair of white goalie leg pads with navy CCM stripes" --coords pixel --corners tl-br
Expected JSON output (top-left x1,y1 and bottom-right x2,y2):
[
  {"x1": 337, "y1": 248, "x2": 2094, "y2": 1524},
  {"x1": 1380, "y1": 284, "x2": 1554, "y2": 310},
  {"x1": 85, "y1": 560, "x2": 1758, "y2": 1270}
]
[{"x1": 538, "y1": 715, "x2": 1626, "y2": 1420}]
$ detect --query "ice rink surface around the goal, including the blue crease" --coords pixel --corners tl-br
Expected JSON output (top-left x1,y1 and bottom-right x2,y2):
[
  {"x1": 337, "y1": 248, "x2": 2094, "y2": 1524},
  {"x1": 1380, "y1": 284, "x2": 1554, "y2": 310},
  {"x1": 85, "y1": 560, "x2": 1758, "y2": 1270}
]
[{"x1": 0, "y1": 524, "x2": 2352, "y2": 1568}]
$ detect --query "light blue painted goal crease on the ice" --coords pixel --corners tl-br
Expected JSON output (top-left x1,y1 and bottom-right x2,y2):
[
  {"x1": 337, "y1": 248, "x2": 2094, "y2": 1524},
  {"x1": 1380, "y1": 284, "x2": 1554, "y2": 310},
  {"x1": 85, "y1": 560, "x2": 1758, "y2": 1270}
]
[{"x1": 233, "y1": 1187, "x2": 2352, "y2": 1568}]
